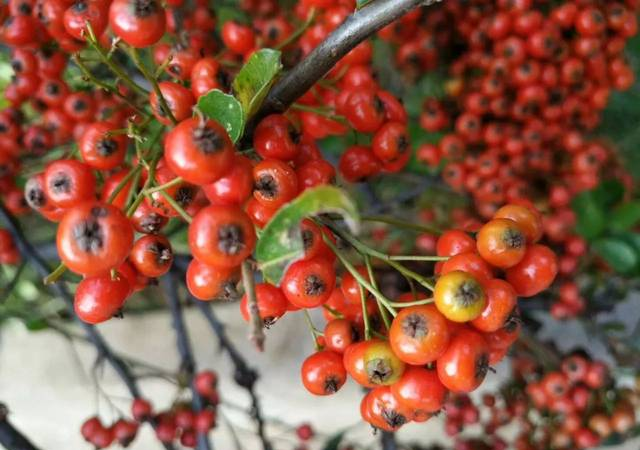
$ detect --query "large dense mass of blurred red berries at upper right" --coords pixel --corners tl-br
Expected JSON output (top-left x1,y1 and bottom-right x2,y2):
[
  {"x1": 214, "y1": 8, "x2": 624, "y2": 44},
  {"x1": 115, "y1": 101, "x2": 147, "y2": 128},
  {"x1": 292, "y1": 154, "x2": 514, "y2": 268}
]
[{"x1": 388, "y1": 0, "x2": 639, "y2": 318}]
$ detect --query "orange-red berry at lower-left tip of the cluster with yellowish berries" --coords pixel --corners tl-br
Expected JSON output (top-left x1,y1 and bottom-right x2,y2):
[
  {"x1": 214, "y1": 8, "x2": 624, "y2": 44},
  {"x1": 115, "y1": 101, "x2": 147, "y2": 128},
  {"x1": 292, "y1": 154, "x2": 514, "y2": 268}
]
[{"x1": 300, "y1": 350, "x2": 347, "y2": 395}]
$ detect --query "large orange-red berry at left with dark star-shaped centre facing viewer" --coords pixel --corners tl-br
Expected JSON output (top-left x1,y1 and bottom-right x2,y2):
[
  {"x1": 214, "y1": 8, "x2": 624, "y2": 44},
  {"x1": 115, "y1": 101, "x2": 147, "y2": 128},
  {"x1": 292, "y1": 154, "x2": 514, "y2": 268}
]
[{"x1": 56, "y1": 202, "x2": 133, "y2": 276}]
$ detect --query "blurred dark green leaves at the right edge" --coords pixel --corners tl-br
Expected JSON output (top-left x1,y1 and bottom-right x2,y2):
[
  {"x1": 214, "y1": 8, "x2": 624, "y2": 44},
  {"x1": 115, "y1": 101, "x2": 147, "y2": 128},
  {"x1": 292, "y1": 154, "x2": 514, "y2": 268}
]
[{"x1": 572, "y1": 180, "x2": 640, "y2": 275}]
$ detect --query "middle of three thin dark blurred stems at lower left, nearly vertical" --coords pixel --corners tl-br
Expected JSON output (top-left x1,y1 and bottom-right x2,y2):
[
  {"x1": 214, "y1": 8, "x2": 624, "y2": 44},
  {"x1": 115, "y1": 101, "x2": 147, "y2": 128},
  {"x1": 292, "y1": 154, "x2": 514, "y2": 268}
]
[{"x1": 160, "y1": 272, "x2": 211, "y2": 450}]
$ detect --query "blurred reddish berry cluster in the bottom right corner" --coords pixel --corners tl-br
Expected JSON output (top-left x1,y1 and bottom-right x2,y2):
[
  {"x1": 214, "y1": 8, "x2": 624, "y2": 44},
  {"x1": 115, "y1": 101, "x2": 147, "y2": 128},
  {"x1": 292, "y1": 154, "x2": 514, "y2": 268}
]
[{"x1": 446, "y1": 353, "x2": 638, "y2": 450}]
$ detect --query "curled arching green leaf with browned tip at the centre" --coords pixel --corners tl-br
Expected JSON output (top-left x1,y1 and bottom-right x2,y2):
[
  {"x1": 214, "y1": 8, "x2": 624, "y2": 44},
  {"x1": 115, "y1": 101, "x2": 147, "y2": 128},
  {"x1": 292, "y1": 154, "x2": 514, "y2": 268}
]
[{"x1": 256, "y1": 186, "x2": 360, "y2": 284}]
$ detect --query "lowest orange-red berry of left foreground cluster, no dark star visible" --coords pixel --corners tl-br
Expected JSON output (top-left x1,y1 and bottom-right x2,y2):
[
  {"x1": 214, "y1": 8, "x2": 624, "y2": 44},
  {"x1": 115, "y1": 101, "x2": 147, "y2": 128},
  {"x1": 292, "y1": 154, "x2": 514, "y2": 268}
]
[{"x1": 73, "y1": 275, "x2": 131, "y2": 324}]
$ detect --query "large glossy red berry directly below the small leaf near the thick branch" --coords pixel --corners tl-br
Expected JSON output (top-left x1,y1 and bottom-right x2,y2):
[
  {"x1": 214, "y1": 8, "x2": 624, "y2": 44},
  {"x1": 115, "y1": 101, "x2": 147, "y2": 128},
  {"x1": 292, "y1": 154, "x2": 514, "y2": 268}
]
[{"x1": 164, "y1": 118, "x2": 234, "y2": 185}]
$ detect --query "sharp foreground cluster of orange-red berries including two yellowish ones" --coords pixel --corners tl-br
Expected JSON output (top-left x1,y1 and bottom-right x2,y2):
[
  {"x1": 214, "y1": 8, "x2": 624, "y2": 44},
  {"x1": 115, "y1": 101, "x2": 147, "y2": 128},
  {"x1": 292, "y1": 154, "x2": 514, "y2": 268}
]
[{"x1": 294, "y1": 205, "x2": 557, "y2": 431}]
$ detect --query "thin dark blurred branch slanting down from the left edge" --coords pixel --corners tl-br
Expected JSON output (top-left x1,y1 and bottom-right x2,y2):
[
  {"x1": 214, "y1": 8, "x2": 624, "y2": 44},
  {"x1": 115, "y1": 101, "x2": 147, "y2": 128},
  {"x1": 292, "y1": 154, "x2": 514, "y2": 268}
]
[{"x1": 0, "y1": 202, "x2": 173, "y2": 450}]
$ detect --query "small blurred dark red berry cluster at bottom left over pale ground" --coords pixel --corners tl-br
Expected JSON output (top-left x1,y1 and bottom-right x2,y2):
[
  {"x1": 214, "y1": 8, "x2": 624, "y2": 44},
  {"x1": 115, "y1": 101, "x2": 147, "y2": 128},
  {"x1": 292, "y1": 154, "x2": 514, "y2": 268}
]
[{"x1": 80, "y1": 370, "x2": 219, "y2": 448}]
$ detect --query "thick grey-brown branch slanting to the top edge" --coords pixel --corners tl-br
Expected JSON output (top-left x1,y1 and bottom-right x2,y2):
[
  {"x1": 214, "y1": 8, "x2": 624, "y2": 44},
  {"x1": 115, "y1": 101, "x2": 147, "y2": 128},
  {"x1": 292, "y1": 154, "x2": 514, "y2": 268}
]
[{"x1": 249, "y1": 0, "x2": 437, "y2": 123}]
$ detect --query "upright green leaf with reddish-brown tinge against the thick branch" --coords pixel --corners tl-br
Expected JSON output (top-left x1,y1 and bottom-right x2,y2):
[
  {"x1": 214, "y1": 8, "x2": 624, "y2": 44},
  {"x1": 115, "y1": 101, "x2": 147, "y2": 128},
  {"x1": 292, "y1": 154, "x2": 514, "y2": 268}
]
[{"x1": 233, "y1": 48, "x2": 282, "y2": 119}]
